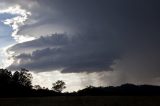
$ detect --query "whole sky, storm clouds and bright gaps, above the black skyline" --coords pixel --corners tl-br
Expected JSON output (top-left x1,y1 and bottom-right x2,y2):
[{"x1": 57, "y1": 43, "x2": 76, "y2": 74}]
[{"x1": 0, "y1": 0, "x2": 160, "y2": 91}]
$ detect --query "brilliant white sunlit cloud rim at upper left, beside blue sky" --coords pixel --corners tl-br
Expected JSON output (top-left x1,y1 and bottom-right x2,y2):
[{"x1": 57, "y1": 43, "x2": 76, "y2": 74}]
[{"x1": 0, "y1": 5, "x2": 34, "y2": 43}]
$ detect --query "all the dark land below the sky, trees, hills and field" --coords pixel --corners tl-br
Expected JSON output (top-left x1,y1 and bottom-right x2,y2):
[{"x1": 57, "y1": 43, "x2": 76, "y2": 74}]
[{"x1": 0, "y1": 69, "x2": 160, "y2": 106}]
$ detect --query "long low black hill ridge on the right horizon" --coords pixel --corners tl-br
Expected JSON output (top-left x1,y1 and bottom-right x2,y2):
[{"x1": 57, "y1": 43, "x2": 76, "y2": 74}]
[{"x1": 75, "y1": 84, "x2": 160, "y2": 96}]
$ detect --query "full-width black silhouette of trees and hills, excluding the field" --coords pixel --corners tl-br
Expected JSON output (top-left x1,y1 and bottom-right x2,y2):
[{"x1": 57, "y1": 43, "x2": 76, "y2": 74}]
[{"x1": 0, "y1": 69, "x2": 160, "y2": 97}]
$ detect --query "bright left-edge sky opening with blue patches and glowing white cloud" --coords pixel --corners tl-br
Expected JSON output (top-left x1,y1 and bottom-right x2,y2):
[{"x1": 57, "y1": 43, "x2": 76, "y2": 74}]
[{"x1": 0, "y1": 5, "x2": 35, "y2": 68}]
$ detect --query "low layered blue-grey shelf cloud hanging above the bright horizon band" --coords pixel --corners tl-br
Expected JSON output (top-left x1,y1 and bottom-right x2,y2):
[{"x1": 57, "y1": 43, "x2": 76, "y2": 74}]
[{"x1": 9, "y1": 33, "x2": 121, "y2": 72}]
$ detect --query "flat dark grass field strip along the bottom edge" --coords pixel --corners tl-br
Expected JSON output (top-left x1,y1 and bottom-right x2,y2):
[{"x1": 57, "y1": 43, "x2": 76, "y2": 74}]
[{"x1": 0, "y1": 96, "x2": 160, "y2": 106}]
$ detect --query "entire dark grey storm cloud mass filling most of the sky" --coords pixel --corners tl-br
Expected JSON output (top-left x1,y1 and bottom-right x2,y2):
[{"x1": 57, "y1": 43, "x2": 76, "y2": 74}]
[{"x1": 3, "y1": 0, "x2": 160, "y2": 84}]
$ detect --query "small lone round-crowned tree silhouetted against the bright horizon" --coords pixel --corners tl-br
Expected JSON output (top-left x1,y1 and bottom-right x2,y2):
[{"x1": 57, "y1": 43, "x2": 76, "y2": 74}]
[{"x1": 52, "y1": 80, "x2": 66, "y2": 92}]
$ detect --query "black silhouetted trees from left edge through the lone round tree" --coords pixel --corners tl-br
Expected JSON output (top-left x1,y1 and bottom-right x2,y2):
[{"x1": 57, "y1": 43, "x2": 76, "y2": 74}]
[{"x1": 0, "y1": 68, "x2": 66, "y2": 97}]
